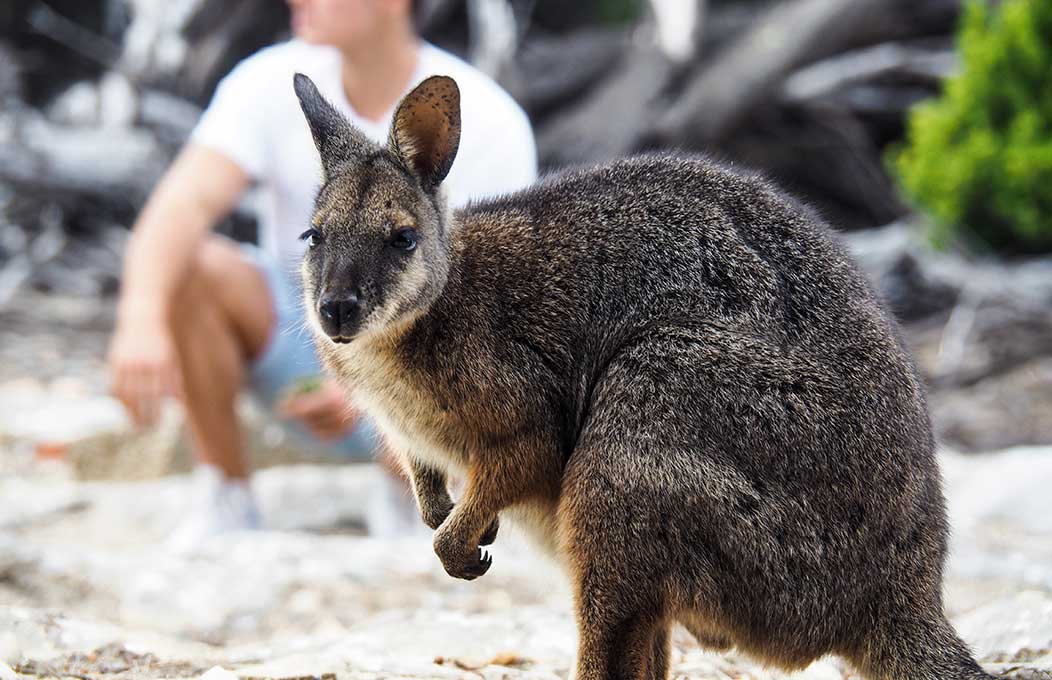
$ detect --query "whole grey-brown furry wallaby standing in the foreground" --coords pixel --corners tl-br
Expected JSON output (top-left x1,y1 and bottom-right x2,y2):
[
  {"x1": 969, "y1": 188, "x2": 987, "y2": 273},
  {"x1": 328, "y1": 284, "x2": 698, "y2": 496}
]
[{"x1": 295, "y1": 70, "x2": 990, "y2": 680}]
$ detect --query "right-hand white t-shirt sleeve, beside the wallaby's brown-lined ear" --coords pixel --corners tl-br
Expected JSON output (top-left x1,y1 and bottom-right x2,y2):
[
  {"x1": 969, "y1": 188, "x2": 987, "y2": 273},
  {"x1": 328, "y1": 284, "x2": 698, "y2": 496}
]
[{"x1": 448, "y1": 100, "x2": 537, "y2": 207}]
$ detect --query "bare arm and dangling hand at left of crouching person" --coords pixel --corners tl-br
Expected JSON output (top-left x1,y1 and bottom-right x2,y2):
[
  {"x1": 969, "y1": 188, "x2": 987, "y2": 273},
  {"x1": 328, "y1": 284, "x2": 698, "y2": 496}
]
[{"x1": 109, "y1": 143, "x2": 249, "y2": 424}]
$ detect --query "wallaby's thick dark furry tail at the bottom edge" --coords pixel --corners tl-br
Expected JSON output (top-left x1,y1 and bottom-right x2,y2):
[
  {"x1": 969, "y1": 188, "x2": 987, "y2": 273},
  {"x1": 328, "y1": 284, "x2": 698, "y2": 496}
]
[{"x1": 851, "y1": 618, "x2": 993, "y2": 680}]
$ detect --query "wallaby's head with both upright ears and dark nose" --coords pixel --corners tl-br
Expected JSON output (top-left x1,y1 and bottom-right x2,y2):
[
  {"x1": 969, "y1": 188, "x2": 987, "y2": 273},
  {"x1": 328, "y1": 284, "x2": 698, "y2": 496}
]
[{"x1": 295, "y1": 74, "x2": 460, "y2": 342}]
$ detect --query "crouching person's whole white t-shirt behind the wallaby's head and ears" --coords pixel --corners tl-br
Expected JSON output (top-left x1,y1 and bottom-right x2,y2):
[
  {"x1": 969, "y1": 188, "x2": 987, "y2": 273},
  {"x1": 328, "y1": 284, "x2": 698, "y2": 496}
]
[{"x1": 190, "y1": 40, "x2": 537, "y2": 265}]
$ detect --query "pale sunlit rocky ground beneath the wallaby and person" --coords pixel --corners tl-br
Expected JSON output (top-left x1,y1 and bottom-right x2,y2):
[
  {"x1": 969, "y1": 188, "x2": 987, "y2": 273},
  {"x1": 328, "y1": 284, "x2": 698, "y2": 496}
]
[{"x1": 0, "y1": 448, "x2": 1052, "y2": 680}]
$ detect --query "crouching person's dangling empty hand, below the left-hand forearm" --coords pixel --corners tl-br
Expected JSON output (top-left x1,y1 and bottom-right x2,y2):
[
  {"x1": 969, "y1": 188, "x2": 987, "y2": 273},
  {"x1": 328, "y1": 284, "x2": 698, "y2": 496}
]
[{"x1": 108, "y1": 318, "x2": 181, "y2": 427}]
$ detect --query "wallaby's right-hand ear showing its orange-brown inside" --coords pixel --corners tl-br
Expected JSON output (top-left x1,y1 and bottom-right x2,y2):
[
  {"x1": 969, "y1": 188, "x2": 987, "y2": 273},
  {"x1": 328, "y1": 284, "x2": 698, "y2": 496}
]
[{"x1": 387, "y1": 76, "x2": 460, "y2": 192}]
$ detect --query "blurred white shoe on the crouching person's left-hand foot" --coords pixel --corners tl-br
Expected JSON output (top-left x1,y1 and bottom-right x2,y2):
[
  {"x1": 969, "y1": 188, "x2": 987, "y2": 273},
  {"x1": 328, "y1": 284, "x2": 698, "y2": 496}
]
[{"x1": 165, "y1": 464, "x2": 261, "y2": 553}]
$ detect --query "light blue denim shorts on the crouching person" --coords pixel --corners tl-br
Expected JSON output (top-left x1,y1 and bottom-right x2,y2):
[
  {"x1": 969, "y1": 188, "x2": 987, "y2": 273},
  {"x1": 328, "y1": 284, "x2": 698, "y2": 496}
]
[{"x1": 242, "y1": 244, "x2": 379, "y2": 461}]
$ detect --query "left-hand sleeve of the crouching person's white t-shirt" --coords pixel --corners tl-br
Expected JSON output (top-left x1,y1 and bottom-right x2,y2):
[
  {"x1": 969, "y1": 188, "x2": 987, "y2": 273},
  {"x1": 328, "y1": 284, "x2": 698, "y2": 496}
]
[{"x1": 190, "y1": 57, "x2": 268, "y2": 180}]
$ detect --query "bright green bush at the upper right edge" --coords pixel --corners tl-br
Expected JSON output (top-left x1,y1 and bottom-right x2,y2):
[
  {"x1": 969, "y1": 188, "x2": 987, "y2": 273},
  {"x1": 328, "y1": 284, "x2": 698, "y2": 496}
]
[{"x1": 890, "y1": 0, "x2": 1052, "y2": 252}]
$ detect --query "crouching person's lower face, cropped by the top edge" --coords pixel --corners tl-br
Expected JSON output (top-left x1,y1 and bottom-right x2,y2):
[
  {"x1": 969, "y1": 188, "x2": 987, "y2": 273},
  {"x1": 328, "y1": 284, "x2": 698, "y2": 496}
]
[{"x1": 286, "y1": 0, "x2": 413, "y2": 47}]
